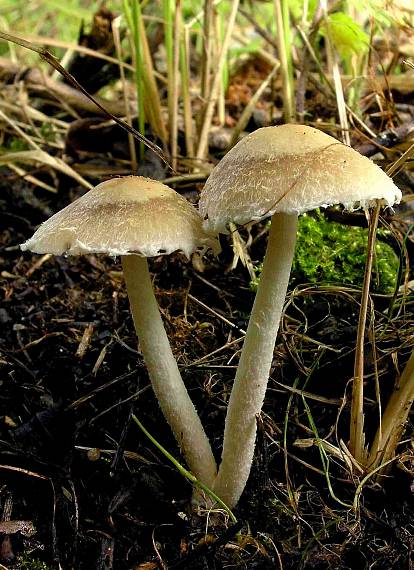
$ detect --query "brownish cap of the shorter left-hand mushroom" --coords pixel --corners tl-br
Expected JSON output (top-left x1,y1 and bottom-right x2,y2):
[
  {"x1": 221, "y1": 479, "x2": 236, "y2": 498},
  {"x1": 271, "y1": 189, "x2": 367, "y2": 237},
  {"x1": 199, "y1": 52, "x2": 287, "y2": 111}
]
[{"x1": 21, "y1": 176, "x2": 216, "y2": 257}]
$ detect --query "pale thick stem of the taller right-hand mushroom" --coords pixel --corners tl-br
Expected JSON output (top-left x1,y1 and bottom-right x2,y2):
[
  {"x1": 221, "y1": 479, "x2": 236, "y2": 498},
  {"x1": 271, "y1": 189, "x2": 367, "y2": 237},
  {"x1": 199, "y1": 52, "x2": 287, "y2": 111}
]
[{"x1": 213, "y1": 214, "x2": 298, "y2": 508}]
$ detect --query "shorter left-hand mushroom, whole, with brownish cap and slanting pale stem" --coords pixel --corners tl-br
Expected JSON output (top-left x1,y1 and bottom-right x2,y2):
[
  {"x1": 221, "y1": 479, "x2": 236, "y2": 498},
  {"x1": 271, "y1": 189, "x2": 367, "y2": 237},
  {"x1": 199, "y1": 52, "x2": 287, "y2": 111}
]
[{"x1": 21, "y1": 176, "x2": 216, "y2": 486}]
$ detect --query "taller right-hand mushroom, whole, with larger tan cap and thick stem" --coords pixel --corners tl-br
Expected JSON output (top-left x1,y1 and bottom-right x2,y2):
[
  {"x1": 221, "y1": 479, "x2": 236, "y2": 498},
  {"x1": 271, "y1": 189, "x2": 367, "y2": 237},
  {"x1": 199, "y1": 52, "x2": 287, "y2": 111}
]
[{"x1": 199, "y1": 124, "x2": 401, "y2": 508}]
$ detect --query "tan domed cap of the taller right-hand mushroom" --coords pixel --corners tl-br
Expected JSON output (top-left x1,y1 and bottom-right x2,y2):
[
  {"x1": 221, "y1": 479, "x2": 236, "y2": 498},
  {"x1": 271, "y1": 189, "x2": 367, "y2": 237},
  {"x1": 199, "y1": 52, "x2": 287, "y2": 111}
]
[{"x1": 199, "y1": 124, "x2": 401, "y2": 232}]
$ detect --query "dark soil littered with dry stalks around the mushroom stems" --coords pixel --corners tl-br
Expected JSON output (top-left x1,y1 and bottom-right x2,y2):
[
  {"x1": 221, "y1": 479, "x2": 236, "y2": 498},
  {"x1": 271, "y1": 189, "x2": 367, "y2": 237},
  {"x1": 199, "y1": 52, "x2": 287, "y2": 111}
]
[{"x1": 0, "y1": 173, "x2": 414, "y2": 570}]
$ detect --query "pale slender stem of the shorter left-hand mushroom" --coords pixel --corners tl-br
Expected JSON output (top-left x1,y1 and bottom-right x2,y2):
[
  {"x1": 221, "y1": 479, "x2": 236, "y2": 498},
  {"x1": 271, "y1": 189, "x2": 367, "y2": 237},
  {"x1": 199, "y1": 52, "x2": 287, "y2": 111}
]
[{"x1": 121, "y1": 255, "x2": 217, "y2": 486}]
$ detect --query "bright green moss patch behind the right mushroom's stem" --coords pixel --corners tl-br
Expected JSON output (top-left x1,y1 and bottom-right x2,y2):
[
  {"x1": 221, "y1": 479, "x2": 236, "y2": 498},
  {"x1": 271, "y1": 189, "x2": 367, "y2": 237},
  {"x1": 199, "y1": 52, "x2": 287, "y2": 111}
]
[{"x1": 252, "y1": 212, "x2": 399, "y2": 293}]
